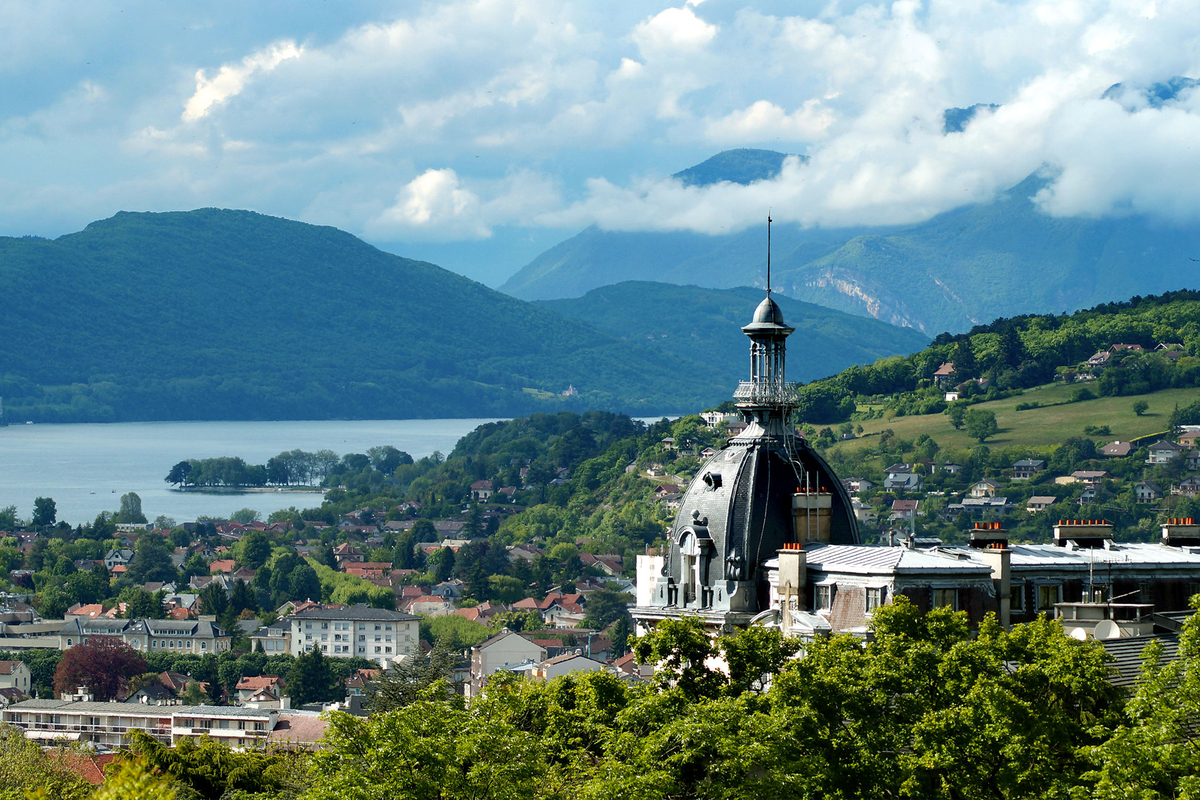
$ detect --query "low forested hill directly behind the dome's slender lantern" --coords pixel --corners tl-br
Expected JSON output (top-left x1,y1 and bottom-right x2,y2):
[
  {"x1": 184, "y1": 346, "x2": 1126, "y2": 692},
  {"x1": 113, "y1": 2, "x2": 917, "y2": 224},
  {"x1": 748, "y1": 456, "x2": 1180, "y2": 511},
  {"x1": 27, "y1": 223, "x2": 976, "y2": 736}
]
[{"x1": 538, "y1": 281, "x2": 929, "y2": 390}]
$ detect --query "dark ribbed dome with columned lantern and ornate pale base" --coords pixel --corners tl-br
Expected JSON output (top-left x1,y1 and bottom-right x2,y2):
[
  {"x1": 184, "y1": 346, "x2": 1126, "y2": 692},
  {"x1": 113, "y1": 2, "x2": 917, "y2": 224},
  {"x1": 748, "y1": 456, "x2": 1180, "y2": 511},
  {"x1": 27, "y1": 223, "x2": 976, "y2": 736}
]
[{"x1": 632, "y1": 289, "x2": 859, "y2": 631}]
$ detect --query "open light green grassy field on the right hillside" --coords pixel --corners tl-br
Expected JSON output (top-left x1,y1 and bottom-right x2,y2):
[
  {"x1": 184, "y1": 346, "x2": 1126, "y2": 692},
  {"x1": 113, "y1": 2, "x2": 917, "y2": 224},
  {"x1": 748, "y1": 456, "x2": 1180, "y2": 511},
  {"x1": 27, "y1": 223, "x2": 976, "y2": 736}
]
[{"x1": 838, "y1": 384, "x2": 1200, "y2": 451}]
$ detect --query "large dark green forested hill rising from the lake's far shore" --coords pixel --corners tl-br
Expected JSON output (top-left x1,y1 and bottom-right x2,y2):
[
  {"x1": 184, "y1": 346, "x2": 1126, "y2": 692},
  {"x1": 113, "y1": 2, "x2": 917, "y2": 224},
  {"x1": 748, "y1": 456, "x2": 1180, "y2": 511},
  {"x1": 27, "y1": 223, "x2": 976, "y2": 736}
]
[{"x1": 0, "y1": 209, "x2": 727, "y2": 421}]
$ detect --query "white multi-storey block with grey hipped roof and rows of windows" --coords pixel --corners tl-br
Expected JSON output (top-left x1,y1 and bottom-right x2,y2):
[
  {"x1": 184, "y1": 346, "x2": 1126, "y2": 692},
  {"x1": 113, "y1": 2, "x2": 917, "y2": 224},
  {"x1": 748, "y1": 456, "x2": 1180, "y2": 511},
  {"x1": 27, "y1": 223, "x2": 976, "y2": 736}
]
[{"x1": 288, "y1": 599, "x2": 417, "y2": 667}]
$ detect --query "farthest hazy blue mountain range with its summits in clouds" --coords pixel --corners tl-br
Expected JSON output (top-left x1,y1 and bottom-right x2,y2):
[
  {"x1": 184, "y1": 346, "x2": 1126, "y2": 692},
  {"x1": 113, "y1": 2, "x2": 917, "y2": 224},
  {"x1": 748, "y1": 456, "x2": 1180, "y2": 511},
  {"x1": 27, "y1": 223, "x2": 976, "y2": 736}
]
[{"x1": 500, "y1": 154, "x2": 1200, "y2": 335}]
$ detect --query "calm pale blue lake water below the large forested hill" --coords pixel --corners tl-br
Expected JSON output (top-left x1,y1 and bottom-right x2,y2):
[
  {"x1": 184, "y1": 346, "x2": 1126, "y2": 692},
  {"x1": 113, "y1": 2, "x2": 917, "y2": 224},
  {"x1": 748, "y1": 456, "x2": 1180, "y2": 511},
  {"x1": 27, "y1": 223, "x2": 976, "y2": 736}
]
[{"x1": 0, "y1": 420, "x2": 501, "y2": 525}]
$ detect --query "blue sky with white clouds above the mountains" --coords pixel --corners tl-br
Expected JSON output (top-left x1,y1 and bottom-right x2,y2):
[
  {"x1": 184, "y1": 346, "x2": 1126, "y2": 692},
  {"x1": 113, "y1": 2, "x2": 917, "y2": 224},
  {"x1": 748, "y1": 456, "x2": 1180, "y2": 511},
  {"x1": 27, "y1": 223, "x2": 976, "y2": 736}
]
[{"x1": 0, "y1": 0, "x2": 1200, "y2": 285}]
